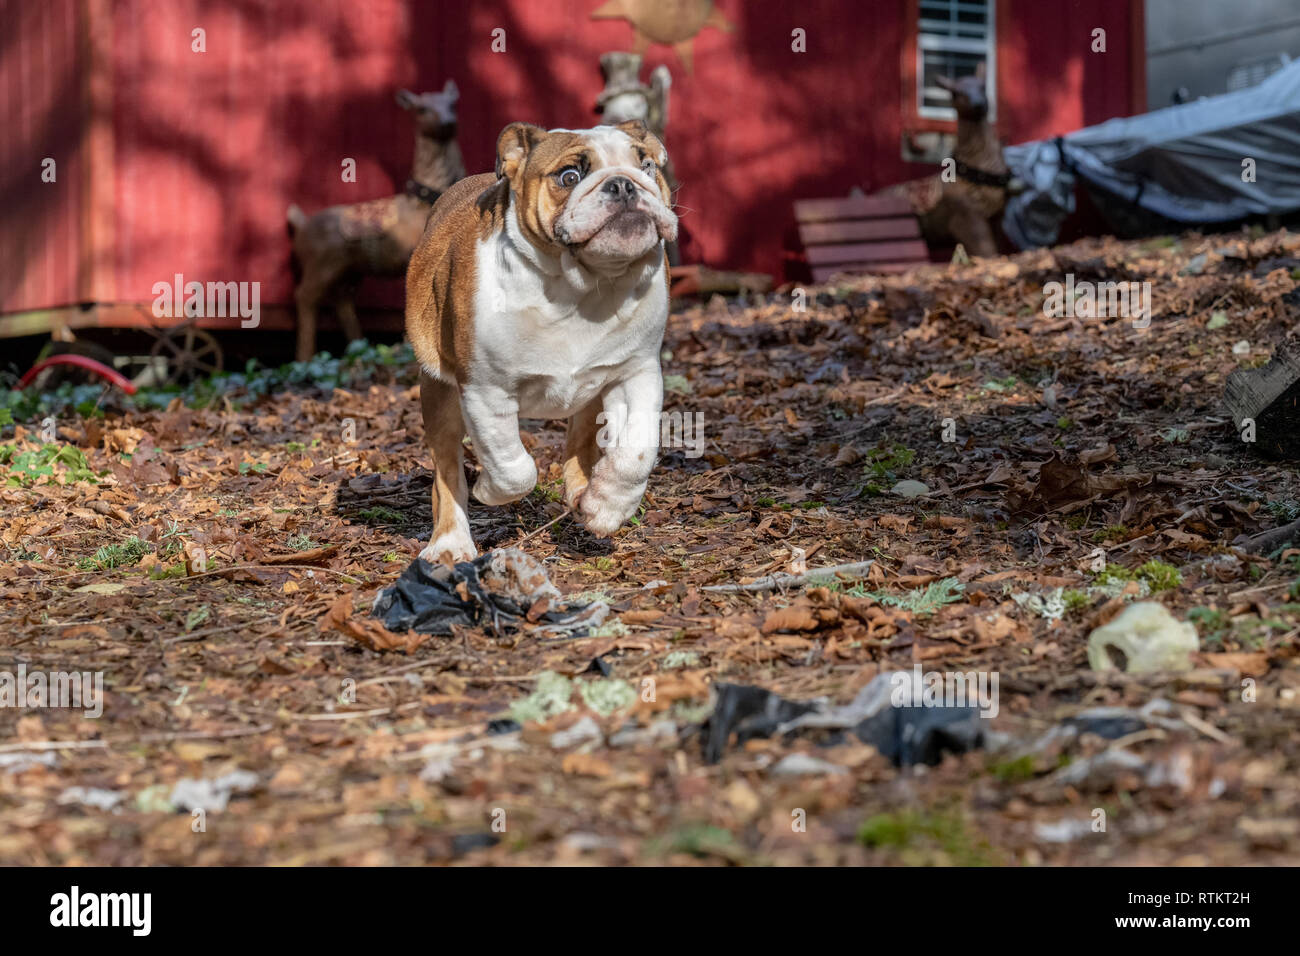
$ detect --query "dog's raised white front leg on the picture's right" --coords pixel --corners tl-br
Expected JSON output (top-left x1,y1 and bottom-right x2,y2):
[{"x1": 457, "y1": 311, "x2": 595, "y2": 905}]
[{"x1": 577, "y1": 364, "x2": 663, "y2": 537}]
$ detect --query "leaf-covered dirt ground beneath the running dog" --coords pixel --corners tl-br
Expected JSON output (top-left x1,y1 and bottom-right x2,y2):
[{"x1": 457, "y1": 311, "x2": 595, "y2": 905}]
[{"x1": 0, "y1": 233, "x2": 1300, "y2": 865}]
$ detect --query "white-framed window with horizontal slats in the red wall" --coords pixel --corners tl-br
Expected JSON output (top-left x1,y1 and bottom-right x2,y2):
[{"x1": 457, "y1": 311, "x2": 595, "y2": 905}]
[{"x1": 917, "y1": 0, "x2": 997, "y2": 120}]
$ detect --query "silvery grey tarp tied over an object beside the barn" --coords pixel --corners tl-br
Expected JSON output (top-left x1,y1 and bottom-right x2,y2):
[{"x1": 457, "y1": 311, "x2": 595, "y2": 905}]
[{"x1": 1002, "y1": 60, "x2": 1300, "y2": 248}]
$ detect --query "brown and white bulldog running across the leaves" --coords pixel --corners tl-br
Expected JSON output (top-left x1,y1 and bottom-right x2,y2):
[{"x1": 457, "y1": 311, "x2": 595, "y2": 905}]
[{"x1": 406, "y1": 121, "x2": 677, "y2": 561}]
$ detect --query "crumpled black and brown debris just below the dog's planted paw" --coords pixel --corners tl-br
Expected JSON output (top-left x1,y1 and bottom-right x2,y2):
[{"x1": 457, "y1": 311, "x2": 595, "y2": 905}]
[{"x1": 371, "y1": 548, "x2": 610, "y2": 635}]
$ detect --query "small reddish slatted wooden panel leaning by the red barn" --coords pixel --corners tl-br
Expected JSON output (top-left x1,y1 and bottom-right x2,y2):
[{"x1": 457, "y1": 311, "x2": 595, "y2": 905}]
[{"x1": 794, "y1": 196, "x2": 930, "y2": 282}]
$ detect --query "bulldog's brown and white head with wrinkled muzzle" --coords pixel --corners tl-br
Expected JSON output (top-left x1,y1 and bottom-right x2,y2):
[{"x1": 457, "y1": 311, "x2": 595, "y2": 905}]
[{"x1": 497, "y1": 121, "x2": 677, "y2": 269}]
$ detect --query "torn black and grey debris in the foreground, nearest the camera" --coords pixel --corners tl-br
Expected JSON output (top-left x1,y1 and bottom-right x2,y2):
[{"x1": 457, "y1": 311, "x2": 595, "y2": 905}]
[{"x1": 703, "y1": 671, "x2": 987, "y2": 766}]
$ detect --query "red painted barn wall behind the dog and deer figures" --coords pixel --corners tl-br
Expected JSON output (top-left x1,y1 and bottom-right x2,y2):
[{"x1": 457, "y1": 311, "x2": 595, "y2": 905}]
[{"x1": 0, "y1": 0, "x2": 1141, "y2": 323}]
